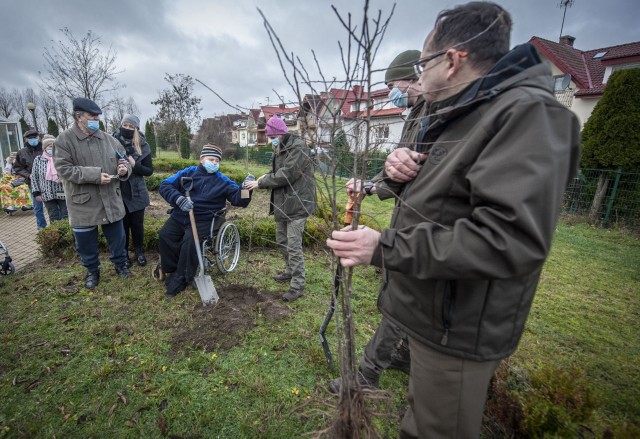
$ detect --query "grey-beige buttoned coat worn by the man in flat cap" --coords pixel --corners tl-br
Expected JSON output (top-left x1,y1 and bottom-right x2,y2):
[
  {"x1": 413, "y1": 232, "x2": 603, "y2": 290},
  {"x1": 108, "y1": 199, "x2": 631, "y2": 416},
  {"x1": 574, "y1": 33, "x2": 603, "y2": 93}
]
[{"x1": 53, "y1": 125, "x2": 131, "y2": 227}]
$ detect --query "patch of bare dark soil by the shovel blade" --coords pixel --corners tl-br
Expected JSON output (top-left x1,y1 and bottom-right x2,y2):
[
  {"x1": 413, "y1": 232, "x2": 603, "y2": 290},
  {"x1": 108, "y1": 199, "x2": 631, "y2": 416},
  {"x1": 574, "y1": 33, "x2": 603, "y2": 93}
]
[{"x1": 171, "y1": 285, "x2": 291, "y2": 354}]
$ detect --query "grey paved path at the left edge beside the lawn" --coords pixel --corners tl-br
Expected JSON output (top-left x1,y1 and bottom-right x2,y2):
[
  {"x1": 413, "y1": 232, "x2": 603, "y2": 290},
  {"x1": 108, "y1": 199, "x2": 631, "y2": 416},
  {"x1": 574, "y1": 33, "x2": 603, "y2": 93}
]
[{"x1": 0, "y1": 210, "x2": 41, "y2": 271}]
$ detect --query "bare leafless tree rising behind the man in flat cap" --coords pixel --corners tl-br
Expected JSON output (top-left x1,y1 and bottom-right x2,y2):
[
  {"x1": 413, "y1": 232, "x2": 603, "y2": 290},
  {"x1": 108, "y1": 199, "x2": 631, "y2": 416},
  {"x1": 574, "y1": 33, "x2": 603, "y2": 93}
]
[{"x1": 40, "y1": 27, "x2": 122, "y2": 105}]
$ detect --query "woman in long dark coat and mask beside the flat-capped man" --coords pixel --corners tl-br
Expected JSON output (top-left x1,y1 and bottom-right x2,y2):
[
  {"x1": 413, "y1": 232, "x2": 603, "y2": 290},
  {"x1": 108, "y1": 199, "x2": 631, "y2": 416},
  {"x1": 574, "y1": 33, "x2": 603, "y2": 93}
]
[{"x1": 113, "y1": 114, "x2": 153, "y2": 266}]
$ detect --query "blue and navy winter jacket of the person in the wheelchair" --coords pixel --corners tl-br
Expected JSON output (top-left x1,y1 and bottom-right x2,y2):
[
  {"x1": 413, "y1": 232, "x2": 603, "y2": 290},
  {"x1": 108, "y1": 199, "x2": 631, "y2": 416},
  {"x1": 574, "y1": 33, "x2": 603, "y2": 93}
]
[{"x1": 160, "y1": 165, "x2": 251, "y2": 225}]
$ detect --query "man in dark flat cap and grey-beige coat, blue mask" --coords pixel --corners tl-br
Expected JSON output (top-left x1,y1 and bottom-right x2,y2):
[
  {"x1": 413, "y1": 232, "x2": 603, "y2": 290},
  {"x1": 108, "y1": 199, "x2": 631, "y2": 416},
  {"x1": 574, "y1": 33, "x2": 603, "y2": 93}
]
[{"x1": 54, "y1": 98, "x2": 131, "y2": 289}]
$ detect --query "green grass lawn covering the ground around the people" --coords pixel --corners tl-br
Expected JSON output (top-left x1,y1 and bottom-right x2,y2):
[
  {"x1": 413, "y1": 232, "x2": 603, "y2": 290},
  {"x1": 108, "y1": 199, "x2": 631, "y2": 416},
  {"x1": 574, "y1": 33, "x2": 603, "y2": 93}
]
[{"x1": 0, "y1": 174, "x2": 640, "y2": 438}]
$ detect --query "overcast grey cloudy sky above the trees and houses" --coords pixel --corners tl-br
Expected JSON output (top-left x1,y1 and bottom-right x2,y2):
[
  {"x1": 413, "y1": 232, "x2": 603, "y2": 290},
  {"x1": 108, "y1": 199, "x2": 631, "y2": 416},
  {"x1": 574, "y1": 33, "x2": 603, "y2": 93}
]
[{"x1": 0, "y1": 0, "x2": 640, "y2": 123}]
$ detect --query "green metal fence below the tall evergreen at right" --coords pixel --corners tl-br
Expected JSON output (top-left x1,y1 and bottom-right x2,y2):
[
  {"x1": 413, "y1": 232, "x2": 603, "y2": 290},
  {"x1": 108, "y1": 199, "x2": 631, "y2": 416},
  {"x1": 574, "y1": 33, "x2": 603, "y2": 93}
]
[{"x1": 562, "y1": 169, "x2": 640, "y2": 229}]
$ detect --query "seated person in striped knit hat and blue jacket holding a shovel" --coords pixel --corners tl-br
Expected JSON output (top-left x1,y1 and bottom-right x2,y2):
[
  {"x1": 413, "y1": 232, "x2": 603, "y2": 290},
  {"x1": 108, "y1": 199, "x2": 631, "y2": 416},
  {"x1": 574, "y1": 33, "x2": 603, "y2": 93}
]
[{"x1": 158, "y1": 144, "x2": 251, "y2": 297}]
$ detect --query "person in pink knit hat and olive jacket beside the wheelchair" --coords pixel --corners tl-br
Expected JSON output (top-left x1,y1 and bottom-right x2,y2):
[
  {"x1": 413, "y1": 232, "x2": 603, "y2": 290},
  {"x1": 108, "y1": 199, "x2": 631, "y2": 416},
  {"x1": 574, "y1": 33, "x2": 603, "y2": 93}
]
[{"x1": 245, "y1": 116, "x2": 317, "y2": 302}]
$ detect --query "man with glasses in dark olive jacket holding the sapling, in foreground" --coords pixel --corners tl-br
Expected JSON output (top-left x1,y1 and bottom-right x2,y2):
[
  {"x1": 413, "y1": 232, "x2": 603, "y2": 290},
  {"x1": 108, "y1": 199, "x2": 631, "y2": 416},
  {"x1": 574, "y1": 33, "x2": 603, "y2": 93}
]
[{"x1": 327, "y1": 2, "x2": 580, "y2": 438}]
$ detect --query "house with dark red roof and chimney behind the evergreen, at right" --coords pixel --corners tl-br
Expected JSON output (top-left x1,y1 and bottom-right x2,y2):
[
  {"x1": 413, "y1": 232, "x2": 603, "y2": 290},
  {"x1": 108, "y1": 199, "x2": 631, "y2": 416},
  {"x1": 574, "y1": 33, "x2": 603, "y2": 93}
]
[{"x1": 529, "y1": 35, "x2": 640, "y2": 126}]
